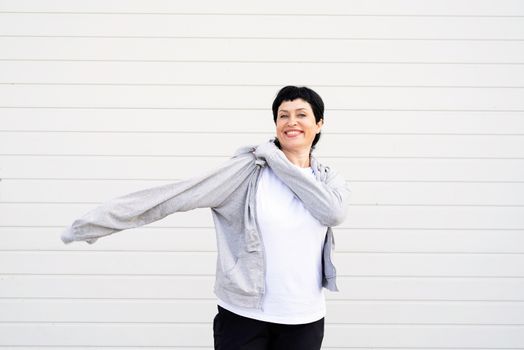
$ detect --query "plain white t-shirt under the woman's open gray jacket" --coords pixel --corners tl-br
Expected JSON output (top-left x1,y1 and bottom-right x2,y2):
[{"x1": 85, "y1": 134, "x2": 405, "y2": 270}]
[{"x1": 218, "y1": 167, "x2": 327, "y2": 324}]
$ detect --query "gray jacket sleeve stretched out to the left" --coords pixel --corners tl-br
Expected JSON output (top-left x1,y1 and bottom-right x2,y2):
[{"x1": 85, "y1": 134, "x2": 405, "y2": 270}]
[{"x1": 61, "y1": 153, "x2": 254, "y2": 243}]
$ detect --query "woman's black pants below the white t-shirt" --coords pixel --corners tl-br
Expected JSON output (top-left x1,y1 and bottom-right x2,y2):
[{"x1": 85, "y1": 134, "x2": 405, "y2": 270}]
[{"x1": 213, "y1": 306, "x2": 324, "y2": 350}]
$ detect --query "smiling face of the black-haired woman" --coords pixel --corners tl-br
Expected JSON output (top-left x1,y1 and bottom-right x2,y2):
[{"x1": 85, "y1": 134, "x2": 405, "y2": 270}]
[{"x1": 276, "y1": 98, "x2": 322, "y2": 152}]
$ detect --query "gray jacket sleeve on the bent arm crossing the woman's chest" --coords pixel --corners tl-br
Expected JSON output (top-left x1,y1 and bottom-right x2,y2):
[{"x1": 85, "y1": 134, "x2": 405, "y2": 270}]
[{"x1": 255, "y1": 141, "x2": 351, "y2": 227}]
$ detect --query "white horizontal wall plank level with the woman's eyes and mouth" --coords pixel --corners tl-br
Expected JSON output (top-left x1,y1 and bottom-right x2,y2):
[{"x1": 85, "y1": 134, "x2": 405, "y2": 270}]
[{"x1": 4, "y1": 109, "x2": 524, "y2": 135}]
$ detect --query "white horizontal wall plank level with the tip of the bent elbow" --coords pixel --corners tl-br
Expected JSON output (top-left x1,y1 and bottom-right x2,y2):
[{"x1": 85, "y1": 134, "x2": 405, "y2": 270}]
[{"x1": 4, "y1": 203, "x2": 524, "y2": 230}]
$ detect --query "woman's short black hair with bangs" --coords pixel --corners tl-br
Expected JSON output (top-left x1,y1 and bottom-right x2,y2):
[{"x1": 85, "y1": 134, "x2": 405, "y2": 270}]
[{"x1": 273, "y1": 85, "x2": 324, "y2": 148}]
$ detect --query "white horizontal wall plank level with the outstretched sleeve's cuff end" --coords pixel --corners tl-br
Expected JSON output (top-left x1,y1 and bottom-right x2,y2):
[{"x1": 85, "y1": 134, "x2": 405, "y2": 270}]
[{"x1": 0, "y1": 227, "x2": 524, "y2": 254}]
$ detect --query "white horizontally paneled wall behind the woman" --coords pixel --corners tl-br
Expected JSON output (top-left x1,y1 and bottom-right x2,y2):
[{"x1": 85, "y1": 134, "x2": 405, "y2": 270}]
[{"x1": 0, "y1": 0, "x2": 524, "y2": 350}]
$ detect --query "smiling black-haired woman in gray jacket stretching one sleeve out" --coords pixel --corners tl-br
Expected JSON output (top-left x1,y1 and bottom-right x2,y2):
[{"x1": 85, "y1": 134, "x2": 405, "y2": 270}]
[{"x1": 62, "y1": 86, "x2": 349, "y2": 350}]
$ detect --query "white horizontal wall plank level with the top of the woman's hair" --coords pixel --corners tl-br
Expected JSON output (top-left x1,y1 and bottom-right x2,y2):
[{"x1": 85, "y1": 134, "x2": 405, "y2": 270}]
[{"x1": 0, "y1": 85, "x2": 524, "y2": 111}]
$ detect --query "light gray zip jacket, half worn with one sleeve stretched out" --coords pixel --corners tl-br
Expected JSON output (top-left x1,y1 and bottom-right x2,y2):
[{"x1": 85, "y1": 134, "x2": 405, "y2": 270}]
[{"x1": 61, "y1": 142, "x2": 349, "y2": 308}]
